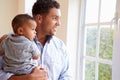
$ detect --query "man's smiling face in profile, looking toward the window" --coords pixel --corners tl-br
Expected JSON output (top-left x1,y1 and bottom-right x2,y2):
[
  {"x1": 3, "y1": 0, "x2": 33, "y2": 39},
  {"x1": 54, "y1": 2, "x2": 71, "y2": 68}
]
[{"x1": 40, "y1": 8, "x2": 61, "y2": 35}]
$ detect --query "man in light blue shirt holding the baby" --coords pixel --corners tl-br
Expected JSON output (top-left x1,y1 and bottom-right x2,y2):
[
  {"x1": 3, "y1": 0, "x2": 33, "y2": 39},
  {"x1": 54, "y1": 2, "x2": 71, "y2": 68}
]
[{"x1": 0, "y1": 0, "x2": 72, "y2": 80}]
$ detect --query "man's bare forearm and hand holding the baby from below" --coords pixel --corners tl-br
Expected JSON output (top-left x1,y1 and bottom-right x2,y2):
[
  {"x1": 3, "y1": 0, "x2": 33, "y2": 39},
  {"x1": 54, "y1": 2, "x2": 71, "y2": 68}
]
[{"x1": 8, "y1": 66, "x2": 48, "y2": 80}]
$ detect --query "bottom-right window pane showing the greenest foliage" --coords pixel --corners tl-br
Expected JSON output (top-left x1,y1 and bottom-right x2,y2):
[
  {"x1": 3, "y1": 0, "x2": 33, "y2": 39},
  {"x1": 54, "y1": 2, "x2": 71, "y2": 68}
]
[{"x1": 98, "y1": 63, "x2": 112, "y2": 80}]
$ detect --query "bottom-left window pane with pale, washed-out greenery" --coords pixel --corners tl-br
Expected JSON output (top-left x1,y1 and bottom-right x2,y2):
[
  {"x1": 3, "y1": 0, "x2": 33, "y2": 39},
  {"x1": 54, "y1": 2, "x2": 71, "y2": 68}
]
[{"x1": 85, "y1": 60, "x2": 95, "y2": 80}]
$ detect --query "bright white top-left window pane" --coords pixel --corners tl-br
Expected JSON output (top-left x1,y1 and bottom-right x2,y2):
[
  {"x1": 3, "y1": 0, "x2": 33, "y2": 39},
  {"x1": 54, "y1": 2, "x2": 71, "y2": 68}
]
[{"x1": 85, "y1": 0, "x2": 99, "y2": 24}]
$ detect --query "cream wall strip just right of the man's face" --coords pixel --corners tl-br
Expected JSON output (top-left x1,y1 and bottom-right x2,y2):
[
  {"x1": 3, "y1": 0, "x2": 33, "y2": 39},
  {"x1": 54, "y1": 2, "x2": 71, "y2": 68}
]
[{"x1": 56, "y1": 0, "x2": 68, "y2": 44}]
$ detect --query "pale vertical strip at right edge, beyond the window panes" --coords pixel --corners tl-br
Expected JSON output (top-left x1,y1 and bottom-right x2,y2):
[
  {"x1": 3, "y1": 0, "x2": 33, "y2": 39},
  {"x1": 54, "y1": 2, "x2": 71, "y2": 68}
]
[{"x1": 112, "y1": 0, "x2": 120, "y2": 80}]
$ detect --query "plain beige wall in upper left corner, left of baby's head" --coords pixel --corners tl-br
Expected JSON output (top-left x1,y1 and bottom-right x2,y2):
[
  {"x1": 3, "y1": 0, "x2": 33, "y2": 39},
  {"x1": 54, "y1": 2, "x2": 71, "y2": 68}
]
[{"x1": 0, "y1": 0, "x2": 18, "y2": 36}]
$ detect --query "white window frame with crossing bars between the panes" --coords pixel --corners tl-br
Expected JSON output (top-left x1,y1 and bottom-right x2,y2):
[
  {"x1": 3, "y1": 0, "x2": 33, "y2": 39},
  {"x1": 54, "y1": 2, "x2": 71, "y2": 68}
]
[{"x1": 77, "y1": 0, "x2": 114, "y2": 80}]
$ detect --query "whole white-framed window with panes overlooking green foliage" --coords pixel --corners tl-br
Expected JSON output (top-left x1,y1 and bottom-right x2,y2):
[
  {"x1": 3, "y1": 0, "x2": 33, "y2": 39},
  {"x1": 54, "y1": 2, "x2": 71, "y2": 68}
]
[{"x1": 80, "y1": 0, "x2": 116, "y2": 80}]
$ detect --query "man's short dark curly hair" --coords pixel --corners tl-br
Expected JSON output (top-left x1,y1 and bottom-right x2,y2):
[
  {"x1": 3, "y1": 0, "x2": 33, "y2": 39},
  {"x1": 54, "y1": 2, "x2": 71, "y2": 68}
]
[{"x1": 32, "y1": 0, "x2": 60, "y2": 16}]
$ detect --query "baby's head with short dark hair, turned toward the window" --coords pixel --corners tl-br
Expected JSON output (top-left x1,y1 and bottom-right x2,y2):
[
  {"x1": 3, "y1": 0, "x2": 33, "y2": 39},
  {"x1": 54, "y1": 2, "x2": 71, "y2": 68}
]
[{"x1": 12, "y1": 14, "x2": 37, "y2": 40}]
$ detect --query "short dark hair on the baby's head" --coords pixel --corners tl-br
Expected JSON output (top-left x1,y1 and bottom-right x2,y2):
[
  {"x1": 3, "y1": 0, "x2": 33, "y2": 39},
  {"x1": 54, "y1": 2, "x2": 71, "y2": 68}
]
[{"x1": 12, "y1": 14, "x2": 34, "y2": 33}]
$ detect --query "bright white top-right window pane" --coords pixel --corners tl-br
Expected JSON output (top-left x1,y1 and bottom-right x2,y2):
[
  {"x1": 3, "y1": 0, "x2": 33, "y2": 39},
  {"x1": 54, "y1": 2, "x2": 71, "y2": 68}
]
[{"x1": 100, "y1": 0, "x2": 116, "y2": 22}]
